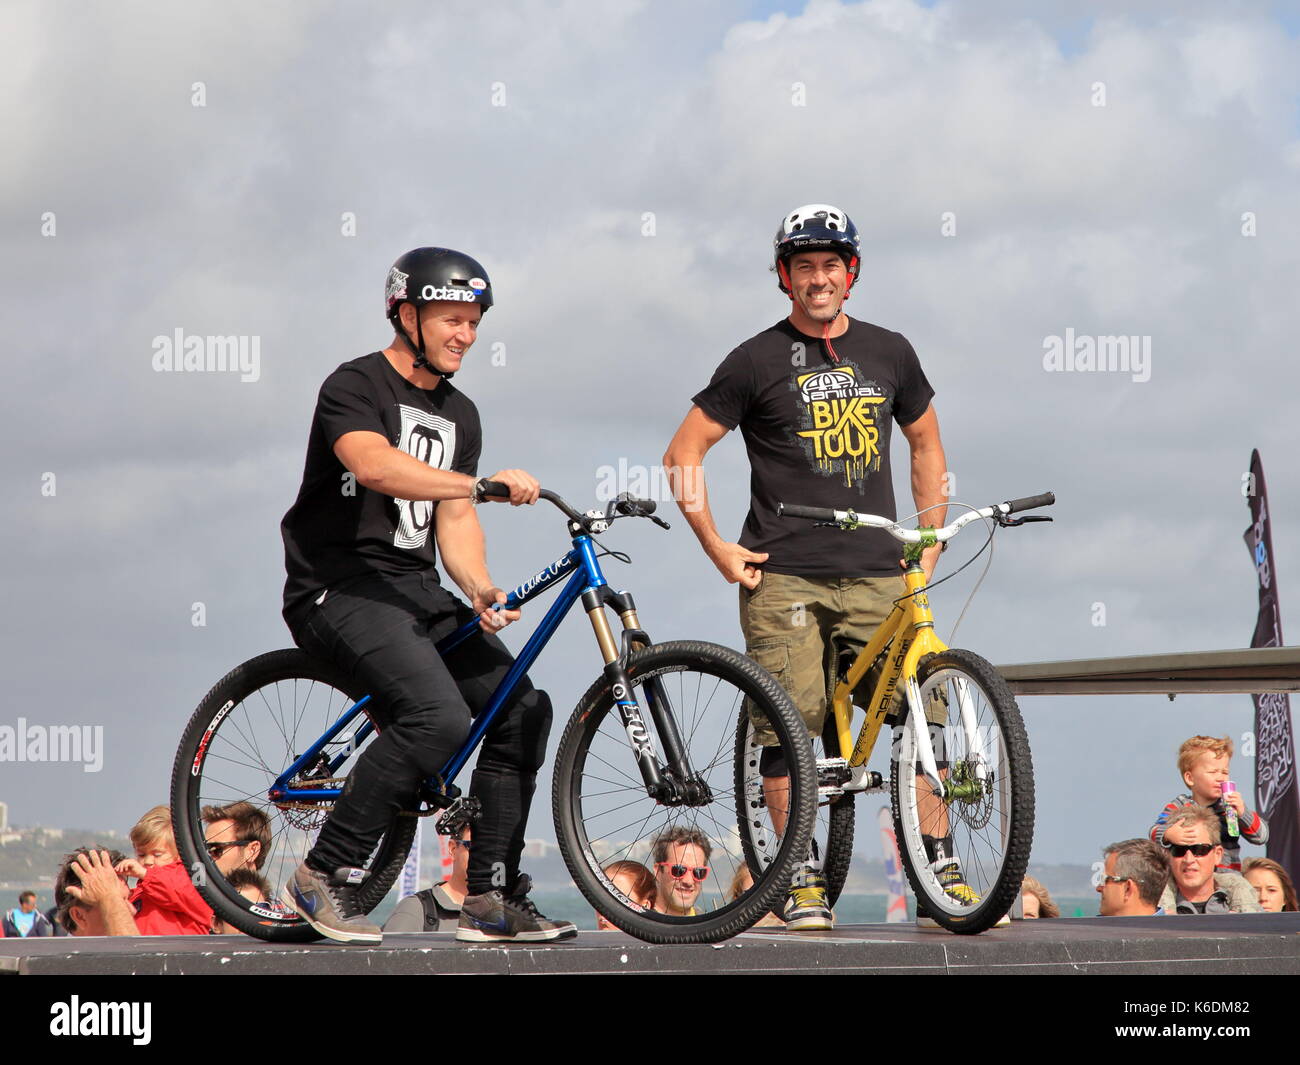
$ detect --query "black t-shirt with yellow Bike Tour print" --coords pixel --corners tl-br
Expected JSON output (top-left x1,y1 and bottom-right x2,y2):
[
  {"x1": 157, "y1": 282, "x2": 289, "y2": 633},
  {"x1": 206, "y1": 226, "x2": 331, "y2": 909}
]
[{"x1": 693, "y1": 319, "x2": 935, "y2": 577}]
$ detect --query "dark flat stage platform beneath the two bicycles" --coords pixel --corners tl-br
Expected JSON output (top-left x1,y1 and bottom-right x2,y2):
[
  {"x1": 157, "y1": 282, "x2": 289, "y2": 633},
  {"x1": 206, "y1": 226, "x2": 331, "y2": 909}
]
[{"x1": 0, "y1": 913, "x2": 1300, "y2": 977}]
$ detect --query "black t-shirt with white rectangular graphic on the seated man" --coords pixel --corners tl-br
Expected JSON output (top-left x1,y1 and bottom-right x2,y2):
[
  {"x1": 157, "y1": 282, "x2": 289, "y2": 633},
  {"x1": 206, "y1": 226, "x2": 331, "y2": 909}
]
[{"x1": 280, "y1": 351, "x2": 482, "y2": 615}]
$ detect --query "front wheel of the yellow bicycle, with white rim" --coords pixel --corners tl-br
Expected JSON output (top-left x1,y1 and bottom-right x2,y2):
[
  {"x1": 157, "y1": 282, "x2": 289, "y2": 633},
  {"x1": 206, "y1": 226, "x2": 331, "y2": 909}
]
[{"x1": 891, "y1": 650, "x2": 1034, "y2": 932}]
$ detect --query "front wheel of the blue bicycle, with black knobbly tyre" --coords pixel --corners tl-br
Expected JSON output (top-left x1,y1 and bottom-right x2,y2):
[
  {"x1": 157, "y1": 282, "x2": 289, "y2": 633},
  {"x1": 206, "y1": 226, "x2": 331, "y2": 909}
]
[{"x1": 553, "y1": 641, "x2": 816, "y2": 943}]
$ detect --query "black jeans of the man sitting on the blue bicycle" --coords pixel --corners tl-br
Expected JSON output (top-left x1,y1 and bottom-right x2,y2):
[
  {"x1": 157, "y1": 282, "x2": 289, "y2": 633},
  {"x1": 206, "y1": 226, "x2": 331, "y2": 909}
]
[{"x1": 289, "y1": 572, "x2": 551, "y2": 895}]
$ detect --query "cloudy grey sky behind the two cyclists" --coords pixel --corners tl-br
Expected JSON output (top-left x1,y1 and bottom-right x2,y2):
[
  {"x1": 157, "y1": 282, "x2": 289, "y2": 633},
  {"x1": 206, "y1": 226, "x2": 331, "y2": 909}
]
[{"x1": 0, "y1": 0, "x2": 1300, "y2": 862}]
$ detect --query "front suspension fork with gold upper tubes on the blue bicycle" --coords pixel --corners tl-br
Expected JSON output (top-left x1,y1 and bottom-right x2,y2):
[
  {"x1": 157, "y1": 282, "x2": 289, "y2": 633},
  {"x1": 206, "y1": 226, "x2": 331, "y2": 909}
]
[{"x1": 582, "y1": 585, "x2": 712, "y2": 806}]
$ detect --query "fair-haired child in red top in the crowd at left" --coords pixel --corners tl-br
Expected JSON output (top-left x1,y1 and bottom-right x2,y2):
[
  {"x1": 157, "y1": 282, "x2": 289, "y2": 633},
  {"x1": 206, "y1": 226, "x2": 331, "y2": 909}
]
[{"x1": 116, "y1": 806, "x2": 212, "y2": 935}]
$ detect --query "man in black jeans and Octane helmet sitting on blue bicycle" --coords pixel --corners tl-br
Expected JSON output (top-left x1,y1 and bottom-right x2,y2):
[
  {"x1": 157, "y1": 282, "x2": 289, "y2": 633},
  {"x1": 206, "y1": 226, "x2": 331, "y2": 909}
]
[{"x1": 281, "y1": 247, "x2": 575, "y2": 943}]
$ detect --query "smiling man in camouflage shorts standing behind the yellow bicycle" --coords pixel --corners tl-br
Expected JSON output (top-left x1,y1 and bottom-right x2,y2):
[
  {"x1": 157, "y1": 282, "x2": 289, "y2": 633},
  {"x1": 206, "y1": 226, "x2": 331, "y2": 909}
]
[{"x1": 663, "y1": 204, "x2": 951, "y2": 930}]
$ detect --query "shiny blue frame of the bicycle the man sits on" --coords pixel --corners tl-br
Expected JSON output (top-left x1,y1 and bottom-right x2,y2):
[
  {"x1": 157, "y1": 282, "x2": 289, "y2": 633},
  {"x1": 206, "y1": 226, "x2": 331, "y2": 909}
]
[{"x1": 268, "y1": 533, "x2": 611, "y2": 802}]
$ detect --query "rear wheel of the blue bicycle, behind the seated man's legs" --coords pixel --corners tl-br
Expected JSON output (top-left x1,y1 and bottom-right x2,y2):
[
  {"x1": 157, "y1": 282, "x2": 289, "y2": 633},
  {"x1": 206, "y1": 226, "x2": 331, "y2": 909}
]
[{"x1": 172, "y1": 649, "x2": 416, "y2": 943}]
